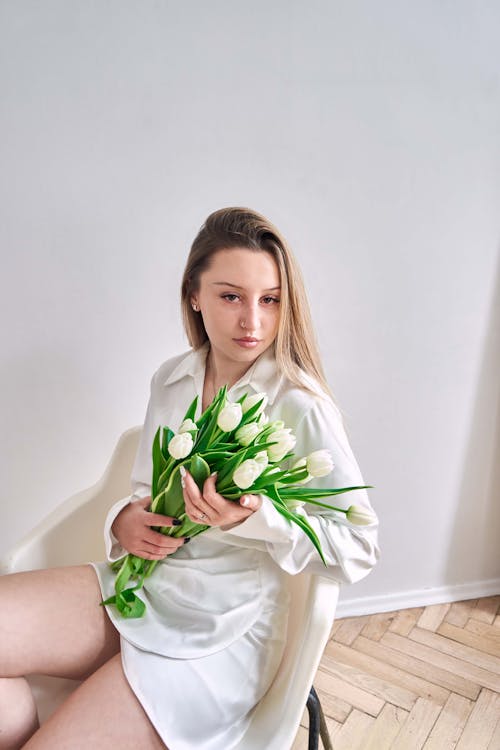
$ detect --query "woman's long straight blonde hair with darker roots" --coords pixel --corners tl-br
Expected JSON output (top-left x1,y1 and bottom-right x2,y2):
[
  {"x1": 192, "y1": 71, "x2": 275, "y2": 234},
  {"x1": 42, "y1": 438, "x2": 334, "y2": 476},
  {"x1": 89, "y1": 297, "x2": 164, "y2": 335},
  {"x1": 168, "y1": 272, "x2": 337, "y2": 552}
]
[{"x1": 181, "y1": 207, "x2": 332, "y2": 396}]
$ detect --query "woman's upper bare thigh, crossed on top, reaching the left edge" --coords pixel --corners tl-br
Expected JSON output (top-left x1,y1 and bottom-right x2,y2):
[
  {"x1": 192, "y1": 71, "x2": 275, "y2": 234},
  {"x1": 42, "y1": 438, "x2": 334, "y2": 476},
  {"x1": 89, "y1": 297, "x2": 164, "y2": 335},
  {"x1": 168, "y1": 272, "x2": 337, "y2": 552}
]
[{"x1": 0, "y1": 565, "x2": 120, "y2": 679}]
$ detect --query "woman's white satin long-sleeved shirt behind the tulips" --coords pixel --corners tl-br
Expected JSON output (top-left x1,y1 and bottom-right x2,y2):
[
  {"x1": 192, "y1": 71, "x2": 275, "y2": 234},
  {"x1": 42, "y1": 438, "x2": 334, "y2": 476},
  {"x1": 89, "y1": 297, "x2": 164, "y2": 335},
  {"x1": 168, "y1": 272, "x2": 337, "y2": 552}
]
[{"x1": 97, "y1": 344, "x2": 378, "y2": 659}]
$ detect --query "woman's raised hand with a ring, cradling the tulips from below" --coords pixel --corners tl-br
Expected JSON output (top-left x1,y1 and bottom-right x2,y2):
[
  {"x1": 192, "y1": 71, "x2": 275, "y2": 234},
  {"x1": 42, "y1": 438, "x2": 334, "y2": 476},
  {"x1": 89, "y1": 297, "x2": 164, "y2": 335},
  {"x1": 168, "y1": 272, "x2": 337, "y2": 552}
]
[{"x1": 181, "y1": 467, "x2": 262, "y2": 530}]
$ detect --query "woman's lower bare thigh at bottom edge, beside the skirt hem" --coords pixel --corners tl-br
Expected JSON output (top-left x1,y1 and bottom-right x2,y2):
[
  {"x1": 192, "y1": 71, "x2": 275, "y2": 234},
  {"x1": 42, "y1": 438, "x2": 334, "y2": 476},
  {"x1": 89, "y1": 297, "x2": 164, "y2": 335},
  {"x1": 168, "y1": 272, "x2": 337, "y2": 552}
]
[{"x1": 24, "y1": 654, "x2": 166, "y2": 750}]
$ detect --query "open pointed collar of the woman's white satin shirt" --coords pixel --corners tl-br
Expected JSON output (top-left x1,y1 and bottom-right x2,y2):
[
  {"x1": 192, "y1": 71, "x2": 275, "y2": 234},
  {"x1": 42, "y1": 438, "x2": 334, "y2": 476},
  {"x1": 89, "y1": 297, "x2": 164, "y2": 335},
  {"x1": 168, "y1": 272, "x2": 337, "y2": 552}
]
[{"x1": 164, "y1": 341, "x2": 283, "y2": 404}]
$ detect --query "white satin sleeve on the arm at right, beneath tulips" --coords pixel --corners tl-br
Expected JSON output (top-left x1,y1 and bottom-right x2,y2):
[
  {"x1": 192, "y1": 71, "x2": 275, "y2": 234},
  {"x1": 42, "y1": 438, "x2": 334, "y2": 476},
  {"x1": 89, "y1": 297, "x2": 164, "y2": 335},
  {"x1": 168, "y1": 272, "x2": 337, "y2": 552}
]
[{"x1": 226, "y1": 396, "x2": 379, "y2": 583}]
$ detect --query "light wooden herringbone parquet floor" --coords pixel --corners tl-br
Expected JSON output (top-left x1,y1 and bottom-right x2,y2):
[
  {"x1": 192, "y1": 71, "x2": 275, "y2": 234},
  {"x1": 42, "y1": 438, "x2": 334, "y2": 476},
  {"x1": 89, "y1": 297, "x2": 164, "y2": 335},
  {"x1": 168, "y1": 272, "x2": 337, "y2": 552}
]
[{"x1": 293, "y1": 596, "x2": 500, "y2": 750}]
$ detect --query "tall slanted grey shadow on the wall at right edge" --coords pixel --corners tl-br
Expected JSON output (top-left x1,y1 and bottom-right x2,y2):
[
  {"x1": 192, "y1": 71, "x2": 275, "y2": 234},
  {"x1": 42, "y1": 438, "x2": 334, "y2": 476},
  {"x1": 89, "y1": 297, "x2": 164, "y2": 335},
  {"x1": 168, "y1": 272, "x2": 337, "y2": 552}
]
[{"x1": 444, "y1": 250, "x2": 500, "y2": 593}]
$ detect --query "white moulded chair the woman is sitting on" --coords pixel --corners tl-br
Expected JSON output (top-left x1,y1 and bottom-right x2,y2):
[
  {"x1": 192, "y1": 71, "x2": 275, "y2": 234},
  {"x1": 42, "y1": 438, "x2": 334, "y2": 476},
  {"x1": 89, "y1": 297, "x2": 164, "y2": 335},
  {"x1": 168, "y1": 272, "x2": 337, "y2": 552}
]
[{"x1": 0, "y1": 427, "x2": 338, "y2": 750}]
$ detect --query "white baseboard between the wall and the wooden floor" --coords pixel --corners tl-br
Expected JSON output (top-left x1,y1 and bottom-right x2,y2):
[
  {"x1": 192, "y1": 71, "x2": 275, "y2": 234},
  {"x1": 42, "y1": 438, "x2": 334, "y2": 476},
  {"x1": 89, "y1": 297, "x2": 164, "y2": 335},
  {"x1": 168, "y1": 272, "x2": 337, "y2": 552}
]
[{"x1": 335, "y1": 578, "x2": 500, "y2": 619}]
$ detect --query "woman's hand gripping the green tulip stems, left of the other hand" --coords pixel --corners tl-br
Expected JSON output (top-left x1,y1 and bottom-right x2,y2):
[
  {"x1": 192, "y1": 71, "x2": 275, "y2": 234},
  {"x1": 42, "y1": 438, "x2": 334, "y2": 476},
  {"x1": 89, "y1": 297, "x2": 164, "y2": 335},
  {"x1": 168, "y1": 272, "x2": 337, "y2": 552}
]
[{"x1": 111, "y1": 497, "x2": 186, "y2": 560}]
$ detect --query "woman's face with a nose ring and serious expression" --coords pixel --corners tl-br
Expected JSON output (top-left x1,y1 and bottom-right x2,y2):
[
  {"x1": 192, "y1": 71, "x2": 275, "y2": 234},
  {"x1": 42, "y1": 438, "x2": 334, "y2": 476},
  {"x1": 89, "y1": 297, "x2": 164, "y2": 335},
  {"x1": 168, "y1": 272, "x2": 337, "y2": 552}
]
[{"x1": 191, "y1": 247, "x2": 280, "y2": 374}]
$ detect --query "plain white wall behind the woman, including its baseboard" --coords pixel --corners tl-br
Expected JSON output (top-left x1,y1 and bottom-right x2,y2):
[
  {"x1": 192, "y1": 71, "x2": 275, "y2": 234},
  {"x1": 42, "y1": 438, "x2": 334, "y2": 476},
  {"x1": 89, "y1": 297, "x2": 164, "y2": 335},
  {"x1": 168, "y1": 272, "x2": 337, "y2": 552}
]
[{"x1": 0, "y1": 0, "x2": 500, "y2": 612}]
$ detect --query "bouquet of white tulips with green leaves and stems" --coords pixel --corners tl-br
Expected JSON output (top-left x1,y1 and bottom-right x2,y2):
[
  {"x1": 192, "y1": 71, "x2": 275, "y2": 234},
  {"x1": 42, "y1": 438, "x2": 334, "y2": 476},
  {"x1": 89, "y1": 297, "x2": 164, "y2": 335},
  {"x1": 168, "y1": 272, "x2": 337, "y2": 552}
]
[{"x1": 103, "y1": 386, "x2": 374, "y2": 617}]
